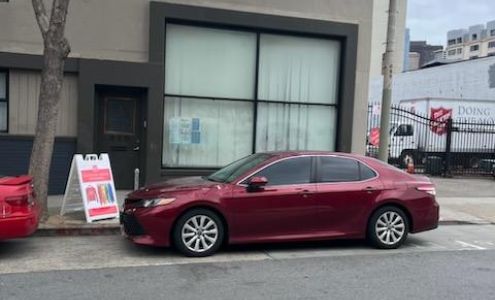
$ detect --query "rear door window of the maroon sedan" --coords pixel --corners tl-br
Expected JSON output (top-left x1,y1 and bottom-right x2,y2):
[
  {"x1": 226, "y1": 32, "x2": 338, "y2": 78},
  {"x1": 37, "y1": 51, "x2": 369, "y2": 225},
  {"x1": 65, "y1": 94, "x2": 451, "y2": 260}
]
[{"x1": 318, "y1": 156, "x2": 360, "y2": 182}]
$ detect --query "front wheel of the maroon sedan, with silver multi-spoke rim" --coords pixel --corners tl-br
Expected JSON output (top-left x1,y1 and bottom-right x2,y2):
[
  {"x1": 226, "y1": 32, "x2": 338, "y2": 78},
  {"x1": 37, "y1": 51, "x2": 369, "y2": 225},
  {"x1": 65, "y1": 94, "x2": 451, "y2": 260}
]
[{"x1": 173, "y1": 208, "x2": 225, "y2": 257}]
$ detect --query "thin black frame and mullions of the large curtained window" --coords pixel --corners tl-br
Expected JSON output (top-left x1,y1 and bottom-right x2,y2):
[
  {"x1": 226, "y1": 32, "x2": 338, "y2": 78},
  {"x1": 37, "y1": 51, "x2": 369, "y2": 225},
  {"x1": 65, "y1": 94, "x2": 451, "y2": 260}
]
[{"x1": 165, "y1": 22, "x2": 346, "y2": 170}]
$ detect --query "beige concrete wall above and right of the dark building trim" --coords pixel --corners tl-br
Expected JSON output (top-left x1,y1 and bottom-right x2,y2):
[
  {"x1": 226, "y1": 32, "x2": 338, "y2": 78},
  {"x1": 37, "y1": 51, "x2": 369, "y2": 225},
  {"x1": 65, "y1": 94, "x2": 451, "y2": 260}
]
[{"x1": 0, "y1": 0, "x2": 380, "y2": 153}]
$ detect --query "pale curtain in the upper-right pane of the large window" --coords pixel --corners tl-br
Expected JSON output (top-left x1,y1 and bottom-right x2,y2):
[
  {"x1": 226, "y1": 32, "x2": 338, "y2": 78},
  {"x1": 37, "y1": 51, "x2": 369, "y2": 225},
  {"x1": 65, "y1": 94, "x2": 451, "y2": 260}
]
[{"x1": 258, "y1": 34, "x2": 340, "y2": 104}]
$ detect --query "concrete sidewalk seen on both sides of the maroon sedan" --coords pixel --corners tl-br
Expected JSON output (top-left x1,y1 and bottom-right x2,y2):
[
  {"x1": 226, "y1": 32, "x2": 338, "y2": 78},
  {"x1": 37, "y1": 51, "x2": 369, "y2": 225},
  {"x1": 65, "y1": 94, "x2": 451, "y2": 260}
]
[{"x1": 36, "y1": 177, "x2": 495, "y2": 235}]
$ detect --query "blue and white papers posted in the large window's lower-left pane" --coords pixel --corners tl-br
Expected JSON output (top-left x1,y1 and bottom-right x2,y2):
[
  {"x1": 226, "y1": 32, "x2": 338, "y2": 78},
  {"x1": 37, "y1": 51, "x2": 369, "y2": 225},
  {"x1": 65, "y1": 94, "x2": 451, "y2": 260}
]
[{"x1": 169, "y1": 117, "x2": 201, "y2": 145}]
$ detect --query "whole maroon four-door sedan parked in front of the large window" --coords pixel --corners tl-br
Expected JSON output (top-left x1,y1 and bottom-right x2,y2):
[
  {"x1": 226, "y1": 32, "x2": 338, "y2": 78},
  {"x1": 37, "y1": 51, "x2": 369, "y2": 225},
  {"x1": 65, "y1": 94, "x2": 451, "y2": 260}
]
[{"x1": 121, "y1": 152, "x2": 439, "y2": 256}]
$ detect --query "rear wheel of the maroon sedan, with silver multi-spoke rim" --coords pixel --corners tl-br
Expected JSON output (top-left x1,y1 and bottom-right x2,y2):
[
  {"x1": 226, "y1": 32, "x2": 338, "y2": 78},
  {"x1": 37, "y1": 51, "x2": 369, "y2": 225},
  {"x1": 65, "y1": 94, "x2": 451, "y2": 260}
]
[{"x1": 367, "y1": 206, "x2": 409, "y2": 249}]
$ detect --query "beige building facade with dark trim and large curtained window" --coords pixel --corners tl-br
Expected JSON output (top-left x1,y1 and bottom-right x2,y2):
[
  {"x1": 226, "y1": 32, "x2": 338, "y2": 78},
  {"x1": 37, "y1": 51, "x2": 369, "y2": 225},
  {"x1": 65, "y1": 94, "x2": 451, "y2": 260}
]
[{"x1": 0, "y1": 0, "x2": 405, "y2": 193}]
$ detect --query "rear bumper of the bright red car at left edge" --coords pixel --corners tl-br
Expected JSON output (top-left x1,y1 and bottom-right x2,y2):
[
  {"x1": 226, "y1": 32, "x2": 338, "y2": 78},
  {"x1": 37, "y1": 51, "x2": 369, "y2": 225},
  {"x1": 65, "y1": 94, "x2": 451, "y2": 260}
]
[{"x1": 0, "y1": 209, "x2": 40, "y2": 240}]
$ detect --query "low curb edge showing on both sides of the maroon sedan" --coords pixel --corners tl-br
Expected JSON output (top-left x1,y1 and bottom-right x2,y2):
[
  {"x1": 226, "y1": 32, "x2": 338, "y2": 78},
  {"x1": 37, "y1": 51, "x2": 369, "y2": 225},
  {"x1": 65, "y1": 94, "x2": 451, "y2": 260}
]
[{"x1": 33, "y1": 220, "x2": 495, "y2": 237}]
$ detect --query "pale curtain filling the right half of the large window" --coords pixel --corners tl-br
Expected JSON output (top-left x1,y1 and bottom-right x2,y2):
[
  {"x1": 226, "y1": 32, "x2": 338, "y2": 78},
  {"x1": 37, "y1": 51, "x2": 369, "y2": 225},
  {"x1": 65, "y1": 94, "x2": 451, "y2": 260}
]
[{"x1": 256, "y1": 34, "x2": 340, "y2": 151}]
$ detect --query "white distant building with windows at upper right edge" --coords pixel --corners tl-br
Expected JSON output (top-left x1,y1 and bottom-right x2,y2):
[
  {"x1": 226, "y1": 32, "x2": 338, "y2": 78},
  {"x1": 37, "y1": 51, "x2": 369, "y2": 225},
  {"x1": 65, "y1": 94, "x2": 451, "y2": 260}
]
[{"x1": 446, "y1": 20, "x2": 495, "y2": 60}]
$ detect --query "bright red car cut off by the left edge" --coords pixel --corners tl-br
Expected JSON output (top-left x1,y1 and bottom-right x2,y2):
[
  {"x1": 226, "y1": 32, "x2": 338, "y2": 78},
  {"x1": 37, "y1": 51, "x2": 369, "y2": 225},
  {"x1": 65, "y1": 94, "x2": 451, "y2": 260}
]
[{"x1": 0, "y1": 175, "x2": 40, "y2": 240}]
